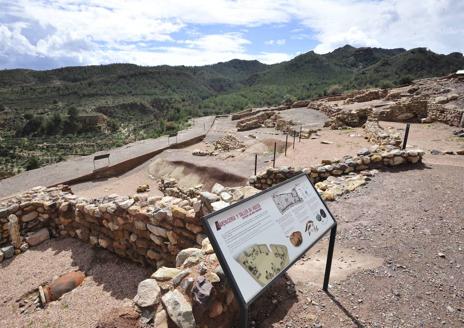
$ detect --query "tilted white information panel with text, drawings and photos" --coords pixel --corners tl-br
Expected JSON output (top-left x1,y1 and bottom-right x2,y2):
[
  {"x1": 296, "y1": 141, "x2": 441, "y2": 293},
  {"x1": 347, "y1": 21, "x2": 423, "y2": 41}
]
[{"x1": 206, "y1": 175, "x2": 335, "y2": 303}]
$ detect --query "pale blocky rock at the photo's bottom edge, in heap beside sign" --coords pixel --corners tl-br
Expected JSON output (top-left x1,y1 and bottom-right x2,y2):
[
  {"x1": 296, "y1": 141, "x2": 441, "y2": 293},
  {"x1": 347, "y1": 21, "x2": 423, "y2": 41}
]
[{"x1": 161, "y1": 289, "x2": 196, "y2": 328}]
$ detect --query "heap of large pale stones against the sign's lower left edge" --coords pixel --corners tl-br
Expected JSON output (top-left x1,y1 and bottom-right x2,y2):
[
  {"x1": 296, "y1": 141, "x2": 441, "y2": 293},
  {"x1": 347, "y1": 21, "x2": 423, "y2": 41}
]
[{"x1": 134, "y1": 238, "x2": 239, "y2": 328}]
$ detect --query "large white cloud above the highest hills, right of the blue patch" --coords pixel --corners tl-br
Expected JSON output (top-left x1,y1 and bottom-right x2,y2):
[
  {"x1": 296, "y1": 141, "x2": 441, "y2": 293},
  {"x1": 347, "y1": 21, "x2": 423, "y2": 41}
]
[{"x1": 289, "y1": 0, "x2": 464, "y2": 53}]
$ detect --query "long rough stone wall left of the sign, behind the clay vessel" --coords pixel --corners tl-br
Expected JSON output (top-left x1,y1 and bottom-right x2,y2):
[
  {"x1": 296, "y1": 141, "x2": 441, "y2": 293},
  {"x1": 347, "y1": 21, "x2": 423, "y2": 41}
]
[{"x1": 0, "y1": 187, "x2": 206, "y2": 266}]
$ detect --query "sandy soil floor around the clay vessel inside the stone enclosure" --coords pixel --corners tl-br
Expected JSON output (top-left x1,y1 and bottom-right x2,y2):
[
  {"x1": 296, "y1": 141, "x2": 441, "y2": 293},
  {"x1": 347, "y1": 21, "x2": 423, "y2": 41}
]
[{"x1": 0, "y1": 239, "x2": 152, "y2": 328}]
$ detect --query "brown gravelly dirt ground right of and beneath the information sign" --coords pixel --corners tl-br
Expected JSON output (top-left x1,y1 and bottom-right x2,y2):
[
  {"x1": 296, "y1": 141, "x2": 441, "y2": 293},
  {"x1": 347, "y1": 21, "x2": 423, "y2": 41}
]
[{"x1": 252, "y1": 162, "x2": 464, "y2": 328}]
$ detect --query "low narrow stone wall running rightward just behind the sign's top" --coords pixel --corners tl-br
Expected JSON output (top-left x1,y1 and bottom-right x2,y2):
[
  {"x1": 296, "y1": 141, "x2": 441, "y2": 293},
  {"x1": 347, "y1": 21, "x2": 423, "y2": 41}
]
[{"x1": 249, "y1": 145, "x2": 424, "y2": 190}]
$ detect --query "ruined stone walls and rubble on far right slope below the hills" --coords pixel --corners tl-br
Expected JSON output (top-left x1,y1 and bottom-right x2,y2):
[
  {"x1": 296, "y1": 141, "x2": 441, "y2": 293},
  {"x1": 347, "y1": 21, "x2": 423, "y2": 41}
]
[{"x1": 308, "y1": 77, "x2": 464, "y2": 129}]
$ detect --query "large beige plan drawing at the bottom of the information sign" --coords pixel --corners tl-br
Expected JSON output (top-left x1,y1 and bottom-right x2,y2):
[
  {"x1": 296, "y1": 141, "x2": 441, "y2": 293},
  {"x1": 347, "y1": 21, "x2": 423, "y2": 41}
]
[{"x1": 236, "y1": 244, "x2": 289, "y2": 286}]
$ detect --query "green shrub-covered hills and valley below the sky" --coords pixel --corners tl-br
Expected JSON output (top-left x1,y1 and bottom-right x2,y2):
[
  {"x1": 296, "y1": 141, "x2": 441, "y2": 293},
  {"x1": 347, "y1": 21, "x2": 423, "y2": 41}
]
[{"x1": 0, "y1": 46, "x2": 464, "y2": 178}]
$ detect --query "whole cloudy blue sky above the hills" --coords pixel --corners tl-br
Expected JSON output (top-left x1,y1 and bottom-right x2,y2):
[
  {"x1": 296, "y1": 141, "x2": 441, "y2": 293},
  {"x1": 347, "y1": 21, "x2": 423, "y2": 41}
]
[{"x1": 0, "y1": 0, "x2": 464, "y2": 69}]
